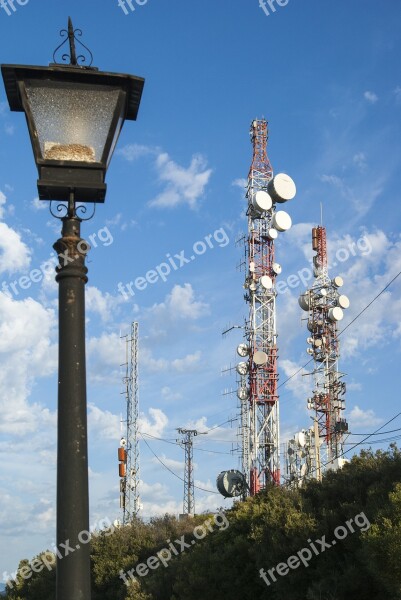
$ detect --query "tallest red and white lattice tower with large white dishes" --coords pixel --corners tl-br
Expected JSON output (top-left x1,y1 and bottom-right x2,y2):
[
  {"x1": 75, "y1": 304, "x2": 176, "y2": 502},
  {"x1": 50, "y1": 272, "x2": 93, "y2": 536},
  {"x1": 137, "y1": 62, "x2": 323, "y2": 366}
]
[{"x1": 237, "y1": 119, "x2": 296, "y2": 495}]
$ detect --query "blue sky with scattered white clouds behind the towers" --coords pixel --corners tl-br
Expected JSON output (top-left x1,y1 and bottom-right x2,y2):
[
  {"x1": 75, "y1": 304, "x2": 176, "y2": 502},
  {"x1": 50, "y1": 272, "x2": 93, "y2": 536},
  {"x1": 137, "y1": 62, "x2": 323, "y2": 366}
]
[{"x1": 0, "y1": 0, "x2": 401, "y2": 572}]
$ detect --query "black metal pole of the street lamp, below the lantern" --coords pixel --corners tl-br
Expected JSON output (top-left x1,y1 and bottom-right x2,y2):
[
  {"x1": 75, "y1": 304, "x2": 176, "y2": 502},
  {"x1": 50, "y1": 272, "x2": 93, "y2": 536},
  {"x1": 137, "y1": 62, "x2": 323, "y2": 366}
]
[{"x1": 54, "y1": 194, "x2": 91, "y2": 600}]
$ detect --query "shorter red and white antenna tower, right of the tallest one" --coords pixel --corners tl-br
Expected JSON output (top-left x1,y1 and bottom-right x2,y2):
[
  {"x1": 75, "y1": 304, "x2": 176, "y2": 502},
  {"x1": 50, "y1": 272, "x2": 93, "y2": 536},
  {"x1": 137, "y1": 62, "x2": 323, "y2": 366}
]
[{"x1": 299, "y1": 226, "x2": 350, "y2": 478}]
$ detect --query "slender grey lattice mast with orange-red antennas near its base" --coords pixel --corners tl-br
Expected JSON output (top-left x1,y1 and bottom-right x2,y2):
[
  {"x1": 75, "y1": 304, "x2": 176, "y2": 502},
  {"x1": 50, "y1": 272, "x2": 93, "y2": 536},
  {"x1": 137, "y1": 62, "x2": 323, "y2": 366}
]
[{"x1": 119, "y1": 322, "x2": 141, "y2": 525}]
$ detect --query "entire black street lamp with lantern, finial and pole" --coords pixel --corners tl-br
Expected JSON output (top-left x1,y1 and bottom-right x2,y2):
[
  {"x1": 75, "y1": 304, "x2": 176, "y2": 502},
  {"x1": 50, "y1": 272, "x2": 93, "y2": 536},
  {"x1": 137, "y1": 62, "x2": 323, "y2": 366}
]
[{"x1": 1, "y1": 19, "x2": 144, "y2": 600}]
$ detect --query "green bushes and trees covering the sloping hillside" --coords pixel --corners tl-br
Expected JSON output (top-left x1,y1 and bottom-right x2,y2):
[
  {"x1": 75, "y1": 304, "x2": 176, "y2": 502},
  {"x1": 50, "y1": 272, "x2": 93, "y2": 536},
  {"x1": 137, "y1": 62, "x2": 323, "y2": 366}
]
[{"x1": 7, "y1": 446, "x2": 401, "y2": 600}]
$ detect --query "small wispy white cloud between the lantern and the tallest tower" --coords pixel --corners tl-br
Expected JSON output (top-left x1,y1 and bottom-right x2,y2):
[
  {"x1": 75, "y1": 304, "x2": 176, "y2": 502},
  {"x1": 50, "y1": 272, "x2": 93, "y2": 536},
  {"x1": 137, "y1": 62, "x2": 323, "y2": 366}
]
[{"x1": 149, "y1": 152, "x2": 212, "y2": 209}]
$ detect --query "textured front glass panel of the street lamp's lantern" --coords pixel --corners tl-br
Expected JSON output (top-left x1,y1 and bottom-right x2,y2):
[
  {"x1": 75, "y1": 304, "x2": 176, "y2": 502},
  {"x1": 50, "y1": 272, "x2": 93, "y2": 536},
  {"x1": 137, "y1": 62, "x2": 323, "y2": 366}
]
[{"x1": 25, "y1": 80, "x2": 121, "y2": 163}]
